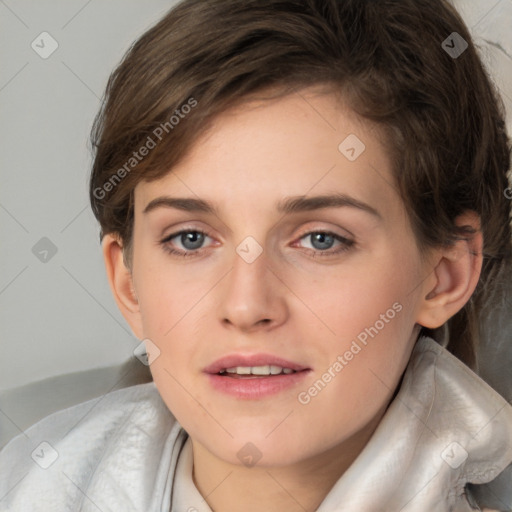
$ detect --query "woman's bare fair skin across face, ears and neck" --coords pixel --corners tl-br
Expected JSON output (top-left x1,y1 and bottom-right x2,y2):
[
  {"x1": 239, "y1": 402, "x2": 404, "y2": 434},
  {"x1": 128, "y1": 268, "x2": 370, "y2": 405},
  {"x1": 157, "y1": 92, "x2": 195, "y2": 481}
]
[{"x1": 103, "y1": 89, "x2": 482, "y2": 512}]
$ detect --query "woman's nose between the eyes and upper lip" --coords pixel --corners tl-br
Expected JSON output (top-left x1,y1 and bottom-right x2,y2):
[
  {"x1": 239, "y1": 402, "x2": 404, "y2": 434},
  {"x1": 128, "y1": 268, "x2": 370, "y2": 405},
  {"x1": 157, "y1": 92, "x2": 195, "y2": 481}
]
[{"x1": 218, "y1": 247, "x2": 288, "y2": 333}]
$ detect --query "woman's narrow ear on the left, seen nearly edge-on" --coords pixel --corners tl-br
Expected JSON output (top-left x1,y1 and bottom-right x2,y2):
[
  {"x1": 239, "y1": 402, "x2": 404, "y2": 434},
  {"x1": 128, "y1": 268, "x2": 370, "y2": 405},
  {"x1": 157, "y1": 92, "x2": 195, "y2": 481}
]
[{"x1": 102, "y1": 234, "x2": 144, "y2": 339}]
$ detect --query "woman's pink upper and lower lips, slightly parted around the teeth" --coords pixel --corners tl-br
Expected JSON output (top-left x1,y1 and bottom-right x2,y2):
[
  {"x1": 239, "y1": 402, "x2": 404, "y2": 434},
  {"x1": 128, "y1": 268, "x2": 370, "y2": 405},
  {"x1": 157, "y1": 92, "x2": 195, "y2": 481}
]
[{"x1": 203, "y1": 354, "x2": 311, "y2": 400}]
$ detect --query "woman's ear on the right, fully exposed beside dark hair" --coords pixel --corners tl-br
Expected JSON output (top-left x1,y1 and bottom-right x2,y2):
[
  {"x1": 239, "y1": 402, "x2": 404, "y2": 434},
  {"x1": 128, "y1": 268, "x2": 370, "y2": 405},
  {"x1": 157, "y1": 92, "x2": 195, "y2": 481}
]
[{"x1": 416, "y1": 212, "x2": 483, "y2": 329}]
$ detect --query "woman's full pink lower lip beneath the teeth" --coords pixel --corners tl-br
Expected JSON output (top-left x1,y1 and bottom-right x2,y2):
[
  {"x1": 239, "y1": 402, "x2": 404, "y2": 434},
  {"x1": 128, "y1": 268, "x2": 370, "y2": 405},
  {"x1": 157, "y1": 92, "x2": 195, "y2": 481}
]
[{"x1": 208, "y1": 370, "x2": 310, "y2": 400}]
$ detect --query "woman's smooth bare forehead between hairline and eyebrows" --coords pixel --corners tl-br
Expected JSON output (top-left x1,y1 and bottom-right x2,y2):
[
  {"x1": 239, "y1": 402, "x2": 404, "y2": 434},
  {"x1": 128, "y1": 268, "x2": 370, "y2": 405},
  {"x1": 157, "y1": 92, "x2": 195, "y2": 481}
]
[{"x1": 135, "y1": 90, "x2": 399, "y2": 221}]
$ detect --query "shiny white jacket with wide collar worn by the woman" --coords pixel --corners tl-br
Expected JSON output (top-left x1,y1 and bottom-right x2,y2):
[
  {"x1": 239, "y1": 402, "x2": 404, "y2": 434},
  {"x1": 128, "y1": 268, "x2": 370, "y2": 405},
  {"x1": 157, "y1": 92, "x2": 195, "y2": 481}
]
[{"x1": 0, "y1": 337, "x2": 512, "y2": 512}]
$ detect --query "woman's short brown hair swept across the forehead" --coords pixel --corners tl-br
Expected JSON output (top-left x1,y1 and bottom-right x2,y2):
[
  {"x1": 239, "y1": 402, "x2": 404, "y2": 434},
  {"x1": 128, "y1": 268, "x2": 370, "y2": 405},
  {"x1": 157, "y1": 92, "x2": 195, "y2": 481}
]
[{"x1": 90, "y1": 0, "x2": 512, "y2": 367}]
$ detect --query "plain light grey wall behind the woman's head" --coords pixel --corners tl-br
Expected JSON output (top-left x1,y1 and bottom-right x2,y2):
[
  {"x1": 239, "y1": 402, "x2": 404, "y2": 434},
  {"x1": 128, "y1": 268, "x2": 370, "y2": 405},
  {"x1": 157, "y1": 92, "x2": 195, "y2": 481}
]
[{"x1": 0, "y1": 0, "x2": 512, "y2": 390}]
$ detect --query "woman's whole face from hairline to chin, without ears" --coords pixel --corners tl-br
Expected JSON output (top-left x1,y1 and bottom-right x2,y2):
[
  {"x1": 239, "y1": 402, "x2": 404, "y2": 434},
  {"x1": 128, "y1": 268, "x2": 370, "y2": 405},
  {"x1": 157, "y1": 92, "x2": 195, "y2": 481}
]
[{"x1": 128, "y1": 90, "x2": 432, "y2": 466}]
